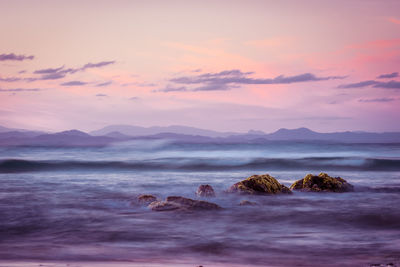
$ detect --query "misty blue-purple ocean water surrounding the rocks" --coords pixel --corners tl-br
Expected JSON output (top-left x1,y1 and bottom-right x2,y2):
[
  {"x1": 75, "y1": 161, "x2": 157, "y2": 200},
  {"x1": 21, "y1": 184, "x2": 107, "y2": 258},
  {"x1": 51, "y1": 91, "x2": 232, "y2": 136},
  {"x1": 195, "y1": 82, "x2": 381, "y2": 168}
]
[{"x1": 0, "y1": 141, "x2": 400, "y2": 266}]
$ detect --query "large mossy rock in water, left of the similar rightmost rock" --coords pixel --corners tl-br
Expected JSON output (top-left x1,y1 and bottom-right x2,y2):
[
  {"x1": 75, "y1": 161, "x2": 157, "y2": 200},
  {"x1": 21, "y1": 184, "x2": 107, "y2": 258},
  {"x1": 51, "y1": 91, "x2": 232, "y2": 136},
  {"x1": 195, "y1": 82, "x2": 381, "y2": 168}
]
[{"x1": 227, "y1": 174, "x2": 292, "y2": 195}]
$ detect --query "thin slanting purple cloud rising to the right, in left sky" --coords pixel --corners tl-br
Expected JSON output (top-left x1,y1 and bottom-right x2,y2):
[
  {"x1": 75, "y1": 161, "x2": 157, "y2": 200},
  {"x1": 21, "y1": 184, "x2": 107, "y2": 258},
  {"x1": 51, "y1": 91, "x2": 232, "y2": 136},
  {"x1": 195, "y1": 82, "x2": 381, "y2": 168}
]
[{"x1": 33, "y1": 61, "x2": 115, "y2": 80}]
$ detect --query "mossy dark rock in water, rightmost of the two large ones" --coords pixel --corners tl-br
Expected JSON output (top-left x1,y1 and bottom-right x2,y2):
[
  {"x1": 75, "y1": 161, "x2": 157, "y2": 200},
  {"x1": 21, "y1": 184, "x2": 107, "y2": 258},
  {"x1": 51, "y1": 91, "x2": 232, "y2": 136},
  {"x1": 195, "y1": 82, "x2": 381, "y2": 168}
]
[{"x1": 290, "y1": 172, "x2": 354, "y2": 193}]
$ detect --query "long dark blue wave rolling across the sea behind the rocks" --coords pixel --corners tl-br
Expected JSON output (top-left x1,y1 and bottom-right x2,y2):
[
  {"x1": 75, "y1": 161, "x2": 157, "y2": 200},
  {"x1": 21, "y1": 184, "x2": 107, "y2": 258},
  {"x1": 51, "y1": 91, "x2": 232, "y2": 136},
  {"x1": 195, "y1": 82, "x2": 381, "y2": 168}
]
[{"x1": 0, "y1": 157, "x2": 400, "y2": 173}]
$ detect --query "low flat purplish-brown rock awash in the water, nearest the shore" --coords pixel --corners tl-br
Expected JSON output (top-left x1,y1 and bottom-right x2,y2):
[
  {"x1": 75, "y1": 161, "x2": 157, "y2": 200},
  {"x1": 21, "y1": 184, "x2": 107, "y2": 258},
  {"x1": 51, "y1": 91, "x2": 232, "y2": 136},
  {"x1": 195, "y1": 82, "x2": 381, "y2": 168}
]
[{"x1": 149, "y1": 196, "x2": 221, "y2": 211}]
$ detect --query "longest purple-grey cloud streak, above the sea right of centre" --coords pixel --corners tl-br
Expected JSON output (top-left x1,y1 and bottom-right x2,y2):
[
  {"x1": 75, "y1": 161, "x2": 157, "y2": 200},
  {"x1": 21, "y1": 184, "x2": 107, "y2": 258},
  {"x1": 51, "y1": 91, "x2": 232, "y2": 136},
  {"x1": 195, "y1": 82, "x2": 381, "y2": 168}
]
[{"x1": 158, "y1": 69, "x2": 345, "y2": 92}]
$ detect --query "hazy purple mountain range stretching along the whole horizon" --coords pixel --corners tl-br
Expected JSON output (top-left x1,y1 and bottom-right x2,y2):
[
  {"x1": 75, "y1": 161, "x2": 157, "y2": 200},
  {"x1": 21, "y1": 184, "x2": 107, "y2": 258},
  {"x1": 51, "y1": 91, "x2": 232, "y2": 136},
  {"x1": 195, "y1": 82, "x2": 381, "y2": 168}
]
[{"x1": 0, "y1": 125, "x2": 400, "y2": 146}]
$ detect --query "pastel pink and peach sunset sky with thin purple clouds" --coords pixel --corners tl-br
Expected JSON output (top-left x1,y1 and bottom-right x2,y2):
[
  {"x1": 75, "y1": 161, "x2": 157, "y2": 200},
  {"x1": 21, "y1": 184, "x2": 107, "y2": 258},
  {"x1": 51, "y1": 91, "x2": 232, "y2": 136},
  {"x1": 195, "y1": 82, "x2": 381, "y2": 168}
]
[{"x1": 0, "y1": 0, "x2": 400, "y2": 132}]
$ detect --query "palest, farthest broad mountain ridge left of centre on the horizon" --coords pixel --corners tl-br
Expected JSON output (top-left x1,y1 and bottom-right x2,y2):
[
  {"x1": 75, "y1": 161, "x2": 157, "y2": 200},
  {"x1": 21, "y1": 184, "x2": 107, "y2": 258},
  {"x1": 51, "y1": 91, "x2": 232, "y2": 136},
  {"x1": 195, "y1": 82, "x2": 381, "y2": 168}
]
[{"x1": 90, "y1": 125, "x2": 236, "y2": 137}]
